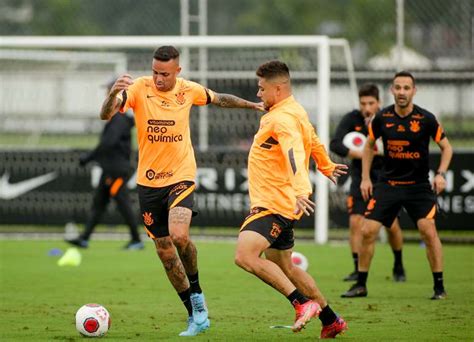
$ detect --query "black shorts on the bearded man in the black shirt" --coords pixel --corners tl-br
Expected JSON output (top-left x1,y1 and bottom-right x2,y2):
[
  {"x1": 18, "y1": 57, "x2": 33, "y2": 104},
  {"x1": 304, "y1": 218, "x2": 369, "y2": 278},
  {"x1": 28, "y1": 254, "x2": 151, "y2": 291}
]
[{"x1": 365, "y1": 183, "x2": 436, "y2": 227}]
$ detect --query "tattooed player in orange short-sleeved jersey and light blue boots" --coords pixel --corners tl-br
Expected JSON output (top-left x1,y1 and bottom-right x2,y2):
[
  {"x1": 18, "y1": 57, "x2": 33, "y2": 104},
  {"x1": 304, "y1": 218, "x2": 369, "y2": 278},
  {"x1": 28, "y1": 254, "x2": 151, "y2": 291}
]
[{"x1": 100, "y1": 46, "x2": 263, "y2": 336}]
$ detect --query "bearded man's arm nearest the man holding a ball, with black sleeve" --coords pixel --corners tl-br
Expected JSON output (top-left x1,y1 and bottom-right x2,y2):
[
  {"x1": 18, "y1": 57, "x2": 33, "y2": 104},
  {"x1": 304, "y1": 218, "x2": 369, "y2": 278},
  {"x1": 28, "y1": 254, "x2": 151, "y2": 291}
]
[{"x1": 360, "y1": 116, "x2": 380, "y2": 201}]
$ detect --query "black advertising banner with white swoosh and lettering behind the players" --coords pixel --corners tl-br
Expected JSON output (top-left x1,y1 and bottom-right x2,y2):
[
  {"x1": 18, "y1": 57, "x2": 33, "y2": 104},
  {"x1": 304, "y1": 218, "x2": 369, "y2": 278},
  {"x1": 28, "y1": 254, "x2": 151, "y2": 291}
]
[{"x1": 0, "y1": 150, "x2": 474, "y2": 230}]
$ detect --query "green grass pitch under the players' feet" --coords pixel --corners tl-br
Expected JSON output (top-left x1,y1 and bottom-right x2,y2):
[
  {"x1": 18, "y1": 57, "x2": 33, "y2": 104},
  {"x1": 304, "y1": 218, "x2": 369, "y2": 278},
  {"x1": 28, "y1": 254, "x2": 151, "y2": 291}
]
[{"x1": 0, "y1": 240, "x2": 474, "y2": 341}]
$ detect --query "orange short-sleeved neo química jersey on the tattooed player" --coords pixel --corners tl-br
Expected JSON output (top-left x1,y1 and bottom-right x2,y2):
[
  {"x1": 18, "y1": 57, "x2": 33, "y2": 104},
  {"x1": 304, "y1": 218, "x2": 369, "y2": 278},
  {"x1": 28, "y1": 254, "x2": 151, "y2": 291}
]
[{"x1": 117, "y1": 76, "x2": 214, "y2": 188}]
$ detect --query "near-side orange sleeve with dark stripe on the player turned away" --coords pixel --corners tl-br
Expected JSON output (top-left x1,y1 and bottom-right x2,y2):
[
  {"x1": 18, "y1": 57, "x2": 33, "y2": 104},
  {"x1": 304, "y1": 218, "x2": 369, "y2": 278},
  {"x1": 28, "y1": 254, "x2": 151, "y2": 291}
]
[{"x1": 274, "y1": 117, "x2": 312, "y2": 196}]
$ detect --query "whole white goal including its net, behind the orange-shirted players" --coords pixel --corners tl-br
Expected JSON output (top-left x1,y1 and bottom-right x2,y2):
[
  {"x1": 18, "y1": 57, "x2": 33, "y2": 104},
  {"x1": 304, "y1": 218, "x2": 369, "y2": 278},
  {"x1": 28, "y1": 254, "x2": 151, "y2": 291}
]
[{"x1": 0, "y1": 36, "x2": 357, "y2": 243}]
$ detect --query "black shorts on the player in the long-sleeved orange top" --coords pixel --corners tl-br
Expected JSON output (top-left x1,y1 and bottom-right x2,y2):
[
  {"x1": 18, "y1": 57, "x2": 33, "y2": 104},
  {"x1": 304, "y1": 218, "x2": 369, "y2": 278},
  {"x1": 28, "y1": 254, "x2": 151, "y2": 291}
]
[{"x1": 240, "y1": 207, "x2": 295, "y2": 250}]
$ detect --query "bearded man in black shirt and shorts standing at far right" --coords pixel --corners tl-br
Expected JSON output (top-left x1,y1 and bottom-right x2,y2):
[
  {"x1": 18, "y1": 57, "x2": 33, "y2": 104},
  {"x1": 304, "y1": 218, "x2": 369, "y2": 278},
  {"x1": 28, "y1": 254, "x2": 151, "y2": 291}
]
[{"x1": 342, "y1": 71, "x2": 453, "y2": 299}]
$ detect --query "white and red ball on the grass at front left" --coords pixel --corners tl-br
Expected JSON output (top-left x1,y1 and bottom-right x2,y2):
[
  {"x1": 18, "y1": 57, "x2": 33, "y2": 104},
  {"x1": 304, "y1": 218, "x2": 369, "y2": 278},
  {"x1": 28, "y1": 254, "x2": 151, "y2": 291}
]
[{"x1": 76, "y1": 304, "x2": 110, "y2": 337}]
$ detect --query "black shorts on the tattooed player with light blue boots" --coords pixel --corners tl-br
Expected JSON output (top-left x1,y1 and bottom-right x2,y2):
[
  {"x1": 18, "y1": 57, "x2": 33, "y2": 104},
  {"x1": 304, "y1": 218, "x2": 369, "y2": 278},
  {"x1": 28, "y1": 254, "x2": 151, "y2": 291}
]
[{"x1": 138, "y1": 181, "x2": 197, "y2": 239}]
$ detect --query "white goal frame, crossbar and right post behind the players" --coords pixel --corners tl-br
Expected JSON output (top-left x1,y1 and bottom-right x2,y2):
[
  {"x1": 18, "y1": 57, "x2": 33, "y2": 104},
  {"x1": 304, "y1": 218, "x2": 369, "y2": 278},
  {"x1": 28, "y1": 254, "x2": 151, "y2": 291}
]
[{"x1": 0, "y1": 36, "x2": 356, "y2": 244}]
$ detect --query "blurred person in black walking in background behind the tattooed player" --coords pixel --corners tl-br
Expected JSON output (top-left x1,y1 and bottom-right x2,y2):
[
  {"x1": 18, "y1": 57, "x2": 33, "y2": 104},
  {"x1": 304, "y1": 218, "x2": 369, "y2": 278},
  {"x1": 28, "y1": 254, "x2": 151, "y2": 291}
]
[{"x1": 66, "y1": 78, "x2": 144, "y2": 250}]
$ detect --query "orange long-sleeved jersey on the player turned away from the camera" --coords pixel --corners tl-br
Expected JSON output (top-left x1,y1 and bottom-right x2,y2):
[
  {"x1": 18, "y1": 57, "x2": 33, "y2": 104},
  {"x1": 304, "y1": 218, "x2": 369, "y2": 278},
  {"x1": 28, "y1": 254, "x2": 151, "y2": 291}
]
[{"x1": 248, "y1": 96, "x2": 335, "y2": 219}]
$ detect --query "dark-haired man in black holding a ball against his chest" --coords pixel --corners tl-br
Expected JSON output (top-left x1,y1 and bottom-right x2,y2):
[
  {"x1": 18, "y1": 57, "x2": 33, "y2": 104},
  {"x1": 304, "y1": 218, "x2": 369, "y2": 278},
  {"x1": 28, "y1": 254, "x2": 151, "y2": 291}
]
[{"x1": 329, "y1": 84, "x2": 406, "y2": 282}]
